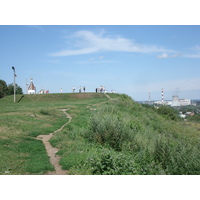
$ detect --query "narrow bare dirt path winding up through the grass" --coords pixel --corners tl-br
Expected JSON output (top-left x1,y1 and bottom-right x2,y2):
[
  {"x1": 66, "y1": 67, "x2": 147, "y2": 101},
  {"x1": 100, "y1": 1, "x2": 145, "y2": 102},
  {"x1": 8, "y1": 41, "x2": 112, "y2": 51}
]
[{"x1": 37, "y1": 109, "x2": 72, "y2": 175}]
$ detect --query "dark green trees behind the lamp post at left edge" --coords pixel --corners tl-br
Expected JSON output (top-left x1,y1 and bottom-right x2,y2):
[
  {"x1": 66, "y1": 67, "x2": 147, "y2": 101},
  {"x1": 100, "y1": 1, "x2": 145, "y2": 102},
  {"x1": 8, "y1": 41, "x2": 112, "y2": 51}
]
[{"x1": 0, "y1": 79, "x2": 23, "y2": 98}]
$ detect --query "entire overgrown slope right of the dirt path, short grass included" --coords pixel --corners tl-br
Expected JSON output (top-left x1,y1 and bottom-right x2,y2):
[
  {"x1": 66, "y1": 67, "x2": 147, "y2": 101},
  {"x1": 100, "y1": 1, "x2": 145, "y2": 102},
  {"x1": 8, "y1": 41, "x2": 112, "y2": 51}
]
[{"x1": 51, "y1": 95, "x2": 200, "y2": 174}]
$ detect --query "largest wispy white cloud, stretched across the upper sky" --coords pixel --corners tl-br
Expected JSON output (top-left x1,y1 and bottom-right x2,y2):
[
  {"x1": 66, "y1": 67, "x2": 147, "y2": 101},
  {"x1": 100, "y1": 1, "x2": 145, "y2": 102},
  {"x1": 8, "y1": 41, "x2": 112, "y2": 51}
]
[{"x1": 51, "y1": 31, "x2": 172, "y2": 56}]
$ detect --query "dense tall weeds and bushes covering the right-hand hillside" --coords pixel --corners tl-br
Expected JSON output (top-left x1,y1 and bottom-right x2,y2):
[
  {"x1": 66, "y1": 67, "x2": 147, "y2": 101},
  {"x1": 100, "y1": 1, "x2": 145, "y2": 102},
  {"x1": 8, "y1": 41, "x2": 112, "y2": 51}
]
[{"x1": 83, "y1": 96, "x2": 200, "y2": 174}]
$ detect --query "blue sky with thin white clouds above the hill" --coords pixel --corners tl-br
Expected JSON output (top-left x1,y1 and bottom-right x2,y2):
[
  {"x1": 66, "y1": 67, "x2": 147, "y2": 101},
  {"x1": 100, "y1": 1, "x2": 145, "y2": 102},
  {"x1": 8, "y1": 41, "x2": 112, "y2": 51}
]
[{"x1": 0, "y1": 25, "x2": 200, "y2": 101}]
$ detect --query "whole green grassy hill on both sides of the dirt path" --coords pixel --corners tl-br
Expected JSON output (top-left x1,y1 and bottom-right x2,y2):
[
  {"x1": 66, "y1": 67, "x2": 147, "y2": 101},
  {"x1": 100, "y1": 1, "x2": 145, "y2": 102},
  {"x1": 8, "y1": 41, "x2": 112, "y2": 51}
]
[{"x1": 0, "y1": 93, "x2": 200, "y2": 174}]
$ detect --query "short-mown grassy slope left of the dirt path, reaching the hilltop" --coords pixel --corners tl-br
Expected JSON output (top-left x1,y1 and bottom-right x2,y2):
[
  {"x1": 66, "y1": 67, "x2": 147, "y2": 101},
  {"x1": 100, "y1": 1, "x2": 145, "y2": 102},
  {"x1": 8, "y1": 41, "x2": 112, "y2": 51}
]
[{"x1": 0, "y1": 93, "x2": 107, "y2": 174}]
